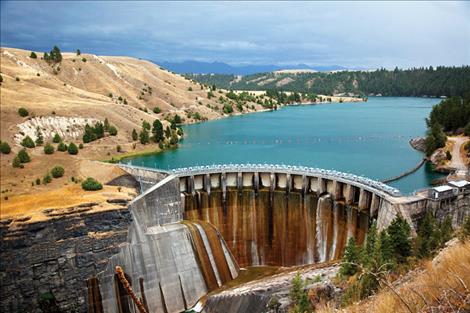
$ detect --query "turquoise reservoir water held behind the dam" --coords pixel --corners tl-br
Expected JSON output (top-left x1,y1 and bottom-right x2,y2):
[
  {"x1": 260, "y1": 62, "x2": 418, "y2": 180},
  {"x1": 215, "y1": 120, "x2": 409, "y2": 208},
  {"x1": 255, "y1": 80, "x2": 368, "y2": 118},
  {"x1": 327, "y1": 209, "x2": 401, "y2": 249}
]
[{"x1": 123, "y1": 97, "x2": 440, "y2": 194}]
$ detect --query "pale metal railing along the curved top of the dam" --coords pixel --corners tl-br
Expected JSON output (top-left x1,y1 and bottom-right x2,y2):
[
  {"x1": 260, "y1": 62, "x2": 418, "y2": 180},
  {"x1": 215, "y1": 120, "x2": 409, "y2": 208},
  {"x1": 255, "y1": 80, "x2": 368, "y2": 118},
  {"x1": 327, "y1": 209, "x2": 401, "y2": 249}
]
[{"x1": 120, "y1": 163, "x2": 401, "y2": 197}]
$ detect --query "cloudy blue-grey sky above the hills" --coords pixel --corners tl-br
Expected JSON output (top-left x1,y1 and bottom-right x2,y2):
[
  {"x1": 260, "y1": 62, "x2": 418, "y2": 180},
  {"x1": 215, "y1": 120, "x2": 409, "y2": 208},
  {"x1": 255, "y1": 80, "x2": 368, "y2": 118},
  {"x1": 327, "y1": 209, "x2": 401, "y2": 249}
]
[{"x1": 1, "y1": 1, "x2": 470, "y2": 68}]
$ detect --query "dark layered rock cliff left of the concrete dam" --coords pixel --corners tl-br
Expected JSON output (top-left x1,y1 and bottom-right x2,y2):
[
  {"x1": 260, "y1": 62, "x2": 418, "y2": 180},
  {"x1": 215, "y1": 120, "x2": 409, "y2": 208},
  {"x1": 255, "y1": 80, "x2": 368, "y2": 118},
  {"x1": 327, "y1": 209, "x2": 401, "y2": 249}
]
[{"x1": 0, "y1": 208, "x2": 131, "y2": 312}]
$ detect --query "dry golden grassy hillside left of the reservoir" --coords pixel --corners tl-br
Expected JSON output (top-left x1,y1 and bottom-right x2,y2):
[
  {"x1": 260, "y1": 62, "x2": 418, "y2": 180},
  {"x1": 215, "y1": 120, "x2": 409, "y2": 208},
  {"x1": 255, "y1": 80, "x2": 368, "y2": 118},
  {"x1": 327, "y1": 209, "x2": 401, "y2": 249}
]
[{"x1": 0, "y1": 48, "x2": 262, "y2": 199}]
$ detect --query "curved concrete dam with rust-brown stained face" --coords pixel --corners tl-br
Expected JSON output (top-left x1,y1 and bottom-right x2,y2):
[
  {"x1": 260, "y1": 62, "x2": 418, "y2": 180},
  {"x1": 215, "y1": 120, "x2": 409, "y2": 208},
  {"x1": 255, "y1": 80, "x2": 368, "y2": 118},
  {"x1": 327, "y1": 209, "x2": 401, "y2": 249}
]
[{"x1": 88, "y1": 164, "x2": 404, "y2": 313}]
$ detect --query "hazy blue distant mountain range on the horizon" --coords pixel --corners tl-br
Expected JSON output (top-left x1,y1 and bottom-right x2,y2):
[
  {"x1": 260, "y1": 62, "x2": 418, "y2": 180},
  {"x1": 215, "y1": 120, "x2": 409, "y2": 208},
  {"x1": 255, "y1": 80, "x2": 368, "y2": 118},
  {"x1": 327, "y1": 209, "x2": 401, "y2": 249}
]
[{"x1": 160, "y1": 61, "x2": 347, "y2": 75}]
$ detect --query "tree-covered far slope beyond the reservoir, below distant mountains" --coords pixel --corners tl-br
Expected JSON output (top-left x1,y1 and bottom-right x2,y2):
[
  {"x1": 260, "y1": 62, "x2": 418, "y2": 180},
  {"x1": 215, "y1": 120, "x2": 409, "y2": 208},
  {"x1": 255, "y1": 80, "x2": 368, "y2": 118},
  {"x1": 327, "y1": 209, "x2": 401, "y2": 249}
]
[{"x1": 186, "y1": 66, "x2": 470, "y2": 97}]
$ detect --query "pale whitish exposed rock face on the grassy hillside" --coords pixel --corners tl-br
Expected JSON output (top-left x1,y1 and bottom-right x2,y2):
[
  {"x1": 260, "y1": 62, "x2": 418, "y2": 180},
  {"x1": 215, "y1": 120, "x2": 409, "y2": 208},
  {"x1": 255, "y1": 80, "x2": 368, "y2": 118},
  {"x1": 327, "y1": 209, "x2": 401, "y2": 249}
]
[{"x1": 15, "y1": 116, "x2": 98, "y2": 144}]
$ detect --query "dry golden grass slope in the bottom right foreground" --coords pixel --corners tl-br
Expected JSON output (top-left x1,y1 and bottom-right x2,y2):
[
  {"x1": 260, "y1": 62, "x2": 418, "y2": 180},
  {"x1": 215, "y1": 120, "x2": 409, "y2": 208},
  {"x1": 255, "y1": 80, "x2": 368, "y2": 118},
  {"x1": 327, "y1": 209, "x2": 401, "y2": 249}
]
[{"x1": 317, "y1": 241, "x2": 470, "y2": 313}]
